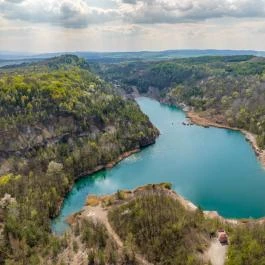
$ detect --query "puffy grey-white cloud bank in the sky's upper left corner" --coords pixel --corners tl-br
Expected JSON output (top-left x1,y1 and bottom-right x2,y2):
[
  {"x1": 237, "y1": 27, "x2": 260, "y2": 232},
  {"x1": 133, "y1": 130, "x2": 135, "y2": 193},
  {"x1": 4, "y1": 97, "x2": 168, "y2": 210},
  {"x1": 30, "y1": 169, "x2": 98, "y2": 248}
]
[{"x1": 0, "y1": 0, "x2": 119, "y2": 28}]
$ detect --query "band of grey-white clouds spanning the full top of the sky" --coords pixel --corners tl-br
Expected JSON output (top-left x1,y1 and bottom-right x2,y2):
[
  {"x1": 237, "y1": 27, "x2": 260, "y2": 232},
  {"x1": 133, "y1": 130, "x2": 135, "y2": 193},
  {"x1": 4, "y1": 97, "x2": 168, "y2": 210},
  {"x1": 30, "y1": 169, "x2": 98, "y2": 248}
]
[{"x1": 0, "y1": 0, "x2": 265, "y2": 28}]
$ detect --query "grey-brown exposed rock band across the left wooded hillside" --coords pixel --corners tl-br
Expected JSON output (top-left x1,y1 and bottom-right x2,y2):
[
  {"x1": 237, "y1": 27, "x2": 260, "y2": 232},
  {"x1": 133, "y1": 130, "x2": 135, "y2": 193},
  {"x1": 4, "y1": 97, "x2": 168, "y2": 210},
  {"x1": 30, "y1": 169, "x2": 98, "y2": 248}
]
[{"x1": 0, "y1": 109, "x2": 159, "y2": 175}]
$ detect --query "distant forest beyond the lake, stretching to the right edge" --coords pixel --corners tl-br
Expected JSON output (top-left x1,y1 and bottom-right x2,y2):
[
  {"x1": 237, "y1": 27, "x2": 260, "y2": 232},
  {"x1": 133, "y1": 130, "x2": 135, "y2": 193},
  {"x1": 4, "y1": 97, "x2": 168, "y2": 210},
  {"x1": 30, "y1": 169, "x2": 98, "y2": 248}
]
[{"x1": 93, "y1": 55, "x2": 265, "y2": 148}]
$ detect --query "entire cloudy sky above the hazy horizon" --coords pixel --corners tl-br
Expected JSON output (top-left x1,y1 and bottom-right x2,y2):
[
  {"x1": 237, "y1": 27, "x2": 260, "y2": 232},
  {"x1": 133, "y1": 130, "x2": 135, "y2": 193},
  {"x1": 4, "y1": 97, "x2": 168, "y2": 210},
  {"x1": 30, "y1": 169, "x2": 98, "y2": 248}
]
[{"x1": 0, "y1": 0, "x2": 265, "y2": 52}]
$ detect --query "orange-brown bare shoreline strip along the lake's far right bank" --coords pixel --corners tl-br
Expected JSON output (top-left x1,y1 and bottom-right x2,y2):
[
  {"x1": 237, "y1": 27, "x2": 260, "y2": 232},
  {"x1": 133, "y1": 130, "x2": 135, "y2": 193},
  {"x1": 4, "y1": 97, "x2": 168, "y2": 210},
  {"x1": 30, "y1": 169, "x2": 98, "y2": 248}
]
[{"x1": 185, "y1": 111, "x2": 265, "y2": 168}]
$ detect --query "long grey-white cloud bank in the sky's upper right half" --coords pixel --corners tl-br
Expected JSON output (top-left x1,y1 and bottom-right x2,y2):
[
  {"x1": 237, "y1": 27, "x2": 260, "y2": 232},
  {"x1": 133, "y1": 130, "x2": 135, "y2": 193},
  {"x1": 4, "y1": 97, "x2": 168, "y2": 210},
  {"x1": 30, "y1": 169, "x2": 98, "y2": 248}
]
[{"x1": 122, "y1": 0, "x2": 265, "y2": 24}]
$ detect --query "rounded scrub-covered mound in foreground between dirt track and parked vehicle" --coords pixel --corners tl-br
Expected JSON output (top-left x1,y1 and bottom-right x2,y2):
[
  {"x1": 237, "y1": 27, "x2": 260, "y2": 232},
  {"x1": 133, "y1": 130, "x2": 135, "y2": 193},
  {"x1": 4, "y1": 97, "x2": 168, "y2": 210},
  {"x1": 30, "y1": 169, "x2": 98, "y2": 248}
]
[{"x1": 109, "y1": 189, "x2": 218, "y2": 265}]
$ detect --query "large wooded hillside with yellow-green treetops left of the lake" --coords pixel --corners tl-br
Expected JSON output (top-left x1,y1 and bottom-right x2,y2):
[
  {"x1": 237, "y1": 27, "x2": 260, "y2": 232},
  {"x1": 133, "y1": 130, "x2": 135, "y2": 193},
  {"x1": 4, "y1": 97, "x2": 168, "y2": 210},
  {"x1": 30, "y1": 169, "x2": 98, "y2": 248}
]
[{"x1": 0, "y1": 55, "x2": 158, "y2": 265}]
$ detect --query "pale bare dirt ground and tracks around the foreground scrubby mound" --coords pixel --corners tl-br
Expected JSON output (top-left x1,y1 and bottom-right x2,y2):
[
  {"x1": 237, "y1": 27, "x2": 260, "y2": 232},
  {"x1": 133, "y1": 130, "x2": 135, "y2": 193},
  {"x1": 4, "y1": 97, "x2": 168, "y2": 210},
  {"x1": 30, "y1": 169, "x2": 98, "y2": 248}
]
[{"x1": 69, "y1": 183, "x2": 231, "y2": 265}]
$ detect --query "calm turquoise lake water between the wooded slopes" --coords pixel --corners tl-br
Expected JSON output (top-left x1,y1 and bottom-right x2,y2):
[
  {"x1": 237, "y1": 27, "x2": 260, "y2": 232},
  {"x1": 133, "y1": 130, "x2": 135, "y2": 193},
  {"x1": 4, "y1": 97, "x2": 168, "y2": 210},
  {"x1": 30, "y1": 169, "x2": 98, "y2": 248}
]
[{"x1": 52, "y1": 98, "x2": 265, "y2": 233}]
